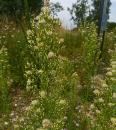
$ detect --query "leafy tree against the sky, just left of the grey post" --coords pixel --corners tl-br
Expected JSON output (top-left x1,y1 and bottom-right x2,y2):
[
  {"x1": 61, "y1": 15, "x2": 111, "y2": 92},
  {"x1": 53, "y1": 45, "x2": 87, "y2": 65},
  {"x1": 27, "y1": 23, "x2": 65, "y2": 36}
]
[{"x1": 68, "y1": 0, "x2": 111, "y2": 26}]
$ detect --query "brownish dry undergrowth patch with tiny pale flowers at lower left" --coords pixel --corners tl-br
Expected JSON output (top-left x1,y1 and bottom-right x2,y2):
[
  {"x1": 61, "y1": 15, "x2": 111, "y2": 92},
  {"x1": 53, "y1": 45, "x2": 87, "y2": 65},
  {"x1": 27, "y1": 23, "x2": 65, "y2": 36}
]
[{"x1": 0, "y1": 88, "x2": 36, "y2": 130}]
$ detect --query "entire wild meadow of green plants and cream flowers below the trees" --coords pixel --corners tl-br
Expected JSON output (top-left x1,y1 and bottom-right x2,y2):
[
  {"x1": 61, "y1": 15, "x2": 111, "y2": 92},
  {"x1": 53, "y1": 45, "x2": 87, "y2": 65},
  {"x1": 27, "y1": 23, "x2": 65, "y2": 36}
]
[{"x1": 0, "y1": 2, "x2": 116, "y2": 130}]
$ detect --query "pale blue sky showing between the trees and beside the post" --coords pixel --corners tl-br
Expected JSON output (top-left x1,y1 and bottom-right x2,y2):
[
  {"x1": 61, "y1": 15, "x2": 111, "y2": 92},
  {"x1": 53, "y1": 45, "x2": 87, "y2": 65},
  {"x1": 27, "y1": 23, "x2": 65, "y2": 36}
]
[{"x1": 50, "y1": 0, "x2": 116, "y2": 28}]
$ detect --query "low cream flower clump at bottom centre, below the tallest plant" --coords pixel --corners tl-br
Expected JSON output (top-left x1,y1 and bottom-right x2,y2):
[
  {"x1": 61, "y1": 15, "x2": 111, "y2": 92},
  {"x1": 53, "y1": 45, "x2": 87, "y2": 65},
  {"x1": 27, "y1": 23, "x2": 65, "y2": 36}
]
[{"x1": 14, "y1": 90, "x2": 68, "y2": 130}]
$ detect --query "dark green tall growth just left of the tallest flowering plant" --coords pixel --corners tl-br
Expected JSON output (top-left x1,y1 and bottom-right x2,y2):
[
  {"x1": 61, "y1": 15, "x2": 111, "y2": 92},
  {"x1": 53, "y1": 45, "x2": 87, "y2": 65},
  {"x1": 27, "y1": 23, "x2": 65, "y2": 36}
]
[{"x1": 6, "y1": 32, "x2": 26, "y2": 88}]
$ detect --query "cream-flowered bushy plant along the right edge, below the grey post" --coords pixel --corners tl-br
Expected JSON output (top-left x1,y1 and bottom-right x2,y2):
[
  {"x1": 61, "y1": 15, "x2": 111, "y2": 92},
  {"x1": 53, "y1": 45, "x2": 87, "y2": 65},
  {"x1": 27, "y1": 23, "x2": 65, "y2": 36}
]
[{"x1": 80, "y1": 46, "x2": 116, "y2": 130}]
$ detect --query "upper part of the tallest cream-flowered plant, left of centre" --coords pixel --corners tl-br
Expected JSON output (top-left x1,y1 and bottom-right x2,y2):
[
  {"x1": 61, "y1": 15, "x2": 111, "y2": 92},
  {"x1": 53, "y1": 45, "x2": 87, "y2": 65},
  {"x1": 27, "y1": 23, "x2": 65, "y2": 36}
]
[{"x1": 25, "y1": 7, "x2": 63, "y2": 90}]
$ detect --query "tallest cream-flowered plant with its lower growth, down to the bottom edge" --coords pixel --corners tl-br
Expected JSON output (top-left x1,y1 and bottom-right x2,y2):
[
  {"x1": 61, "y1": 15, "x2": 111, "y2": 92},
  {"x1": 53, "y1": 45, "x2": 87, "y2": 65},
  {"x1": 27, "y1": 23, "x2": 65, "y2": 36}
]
[{"x1": 14, "y1": 7, "x2": 78, "y2": 130}]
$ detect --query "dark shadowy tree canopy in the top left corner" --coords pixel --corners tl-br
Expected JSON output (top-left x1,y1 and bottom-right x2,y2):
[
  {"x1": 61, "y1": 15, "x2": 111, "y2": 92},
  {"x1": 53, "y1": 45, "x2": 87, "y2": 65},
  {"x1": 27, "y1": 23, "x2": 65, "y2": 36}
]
[{"x1": 0, "y1": 0, "x2": 43, "y2": 17}]
